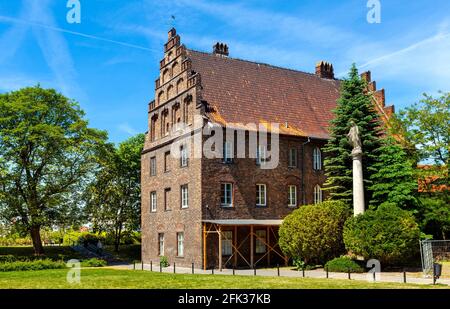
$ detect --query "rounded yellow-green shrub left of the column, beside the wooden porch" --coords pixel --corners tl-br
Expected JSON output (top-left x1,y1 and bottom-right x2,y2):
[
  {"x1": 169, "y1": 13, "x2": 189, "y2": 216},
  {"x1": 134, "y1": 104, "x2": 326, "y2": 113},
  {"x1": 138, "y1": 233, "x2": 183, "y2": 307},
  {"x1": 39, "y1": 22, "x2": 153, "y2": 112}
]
[{"x1": 279, "y1": 201, "x2": 350, "y2": 265}]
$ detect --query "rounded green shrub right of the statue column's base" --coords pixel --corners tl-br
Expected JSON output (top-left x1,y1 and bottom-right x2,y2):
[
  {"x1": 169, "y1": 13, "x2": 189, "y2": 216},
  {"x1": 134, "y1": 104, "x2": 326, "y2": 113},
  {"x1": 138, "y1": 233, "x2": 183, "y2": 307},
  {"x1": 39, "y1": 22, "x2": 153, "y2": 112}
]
[{"x1": 344, "y1": 204, "x2": 420, "y2": 265}]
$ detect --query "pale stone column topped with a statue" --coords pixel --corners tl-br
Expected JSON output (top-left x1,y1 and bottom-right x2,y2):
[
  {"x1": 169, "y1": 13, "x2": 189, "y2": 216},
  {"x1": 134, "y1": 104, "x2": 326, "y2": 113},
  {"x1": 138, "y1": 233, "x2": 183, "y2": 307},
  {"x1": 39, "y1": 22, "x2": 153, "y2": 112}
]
[{"x1": 347, "y1": 120, "x2": 364, "y2": 216}]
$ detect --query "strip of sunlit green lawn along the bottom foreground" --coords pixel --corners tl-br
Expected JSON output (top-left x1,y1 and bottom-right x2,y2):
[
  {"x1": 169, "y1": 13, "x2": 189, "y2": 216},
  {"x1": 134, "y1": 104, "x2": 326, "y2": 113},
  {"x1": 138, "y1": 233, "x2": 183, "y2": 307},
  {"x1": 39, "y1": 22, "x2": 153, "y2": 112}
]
[{"x1": 0, "y1": 268, "x2": 442, "y2": 289}]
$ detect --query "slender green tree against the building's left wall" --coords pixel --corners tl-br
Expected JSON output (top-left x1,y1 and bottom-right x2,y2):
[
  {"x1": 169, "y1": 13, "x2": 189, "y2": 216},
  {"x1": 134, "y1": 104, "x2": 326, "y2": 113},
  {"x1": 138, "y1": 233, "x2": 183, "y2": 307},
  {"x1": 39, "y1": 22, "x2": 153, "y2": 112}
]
[{"x1": 85, "y1": 134, "x2": 145, "y2": 252}]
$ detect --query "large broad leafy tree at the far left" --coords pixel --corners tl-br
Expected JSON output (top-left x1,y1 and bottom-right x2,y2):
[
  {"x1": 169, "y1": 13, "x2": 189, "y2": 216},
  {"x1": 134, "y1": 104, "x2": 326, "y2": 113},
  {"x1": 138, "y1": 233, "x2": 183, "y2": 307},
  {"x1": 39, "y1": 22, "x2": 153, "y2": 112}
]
[{"x1": 0, "y1": 86, "x2": 107, "y2": 254}]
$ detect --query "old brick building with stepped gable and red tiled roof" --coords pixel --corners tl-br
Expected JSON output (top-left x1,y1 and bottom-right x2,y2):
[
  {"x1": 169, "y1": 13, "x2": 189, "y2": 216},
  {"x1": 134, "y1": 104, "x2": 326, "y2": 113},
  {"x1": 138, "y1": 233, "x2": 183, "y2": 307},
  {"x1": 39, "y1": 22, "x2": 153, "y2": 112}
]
[{"x1": 142, "y1": 29, "x2": 393, "y2": 268}]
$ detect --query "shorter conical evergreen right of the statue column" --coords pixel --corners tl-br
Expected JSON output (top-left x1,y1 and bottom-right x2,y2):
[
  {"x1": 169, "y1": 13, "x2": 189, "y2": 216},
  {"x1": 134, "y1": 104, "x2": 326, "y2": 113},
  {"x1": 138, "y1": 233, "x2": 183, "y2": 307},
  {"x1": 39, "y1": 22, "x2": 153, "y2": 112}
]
[{"x1": 370, "y1": 136, "x2": 417, "y2": 210}]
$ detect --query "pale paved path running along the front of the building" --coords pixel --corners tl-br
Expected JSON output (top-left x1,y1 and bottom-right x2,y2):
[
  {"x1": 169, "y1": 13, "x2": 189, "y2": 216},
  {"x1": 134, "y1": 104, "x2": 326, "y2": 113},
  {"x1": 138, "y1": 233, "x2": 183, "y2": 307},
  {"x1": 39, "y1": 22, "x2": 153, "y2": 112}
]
[{"x1": 110, "y1": 264, "x2": 450, "y2": 285}]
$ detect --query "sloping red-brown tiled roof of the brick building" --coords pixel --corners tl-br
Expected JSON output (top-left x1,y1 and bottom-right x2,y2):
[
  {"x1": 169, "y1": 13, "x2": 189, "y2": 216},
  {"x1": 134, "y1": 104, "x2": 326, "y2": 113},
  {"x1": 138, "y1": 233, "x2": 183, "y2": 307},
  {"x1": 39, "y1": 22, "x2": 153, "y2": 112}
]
[{"x1": 187, "y1": 50, "x2": 340, "y2": 139}]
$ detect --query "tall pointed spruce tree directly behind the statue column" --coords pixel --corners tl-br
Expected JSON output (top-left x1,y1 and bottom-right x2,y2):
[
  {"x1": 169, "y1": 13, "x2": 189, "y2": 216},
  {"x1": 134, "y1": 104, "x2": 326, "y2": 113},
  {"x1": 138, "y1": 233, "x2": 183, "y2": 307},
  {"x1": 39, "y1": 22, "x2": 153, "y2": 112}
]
[{"x1": 324, "y1": 64, "x2": 382, "y2": 206}]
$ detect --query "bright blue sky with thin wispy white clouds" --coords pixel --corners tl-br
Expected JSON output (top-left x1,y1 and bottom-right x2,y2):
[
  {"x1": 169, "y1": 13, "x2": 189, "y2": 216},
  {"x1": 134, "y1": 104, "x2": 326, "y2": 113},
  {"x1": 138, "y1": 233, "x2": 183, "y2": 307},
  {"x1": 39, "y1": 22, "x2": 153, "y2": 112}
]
[{"x1": 0, "y1": 0, "x2": 450, "y2": 142}]
